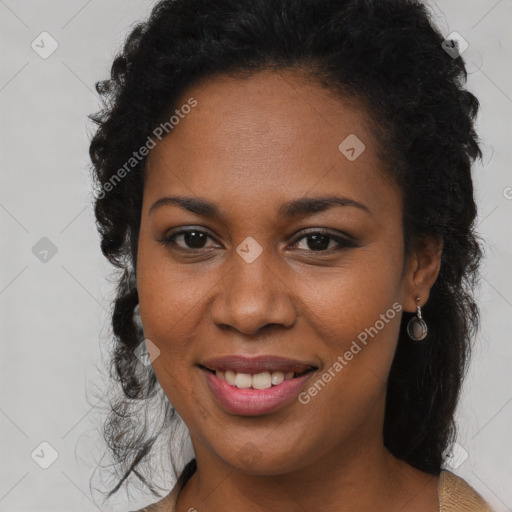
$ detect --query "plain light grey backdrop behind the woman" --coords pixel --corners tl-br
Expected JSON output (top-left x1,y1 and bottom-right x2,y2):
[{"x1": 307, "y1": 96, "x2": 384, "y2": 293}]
[{"x1": 0, "y1": 0, "x2": 512, "y2": 512}]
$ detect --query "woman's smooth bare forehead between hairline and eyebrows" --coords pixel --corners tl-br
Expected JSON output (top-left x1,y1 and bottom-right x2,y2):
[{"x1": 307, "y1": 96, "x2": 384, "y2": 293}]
[{"x1": 145, "y1": 71, "x2": 397, "y2": 218}]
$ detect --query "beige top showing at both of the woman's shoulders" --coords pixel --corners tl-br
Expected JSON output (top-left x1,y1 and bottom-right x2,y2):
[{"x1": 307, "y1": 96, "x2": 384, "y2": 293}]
[{"x1": 131, "y1": 471, "x2": 492, "y2": 512}]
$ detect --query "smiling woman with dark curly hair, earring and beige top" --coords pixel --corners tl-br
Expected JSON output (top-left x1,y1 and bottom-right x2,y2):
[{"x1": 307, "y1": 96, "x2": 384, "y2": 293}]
[{"x1": 90, "y1": 0, "x2": 489, "y2": 512}]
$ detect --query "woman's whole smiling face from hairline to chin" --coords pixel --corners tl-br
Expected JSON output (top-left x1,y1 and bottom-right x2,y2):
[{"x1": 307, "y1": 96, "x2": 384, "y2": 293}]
[{"x1": 137, "y1": 71, "x2": 432, "y2": 474}]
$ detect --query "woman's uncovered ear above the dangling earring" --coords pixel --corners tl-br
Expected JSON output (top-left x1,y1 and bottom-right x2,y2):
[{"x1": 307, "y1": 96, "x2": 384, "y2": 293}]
[{"x1": 403, "y1": 235, "x2": 443, "y2": 313}]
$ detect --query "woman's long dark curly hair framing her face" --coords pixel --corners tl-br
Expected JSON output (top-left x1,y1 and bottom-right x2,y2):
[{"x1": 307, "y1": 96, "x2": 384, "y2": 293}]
[{"x1": 90, "y1": 0, "x2": 482, "y2": 497}]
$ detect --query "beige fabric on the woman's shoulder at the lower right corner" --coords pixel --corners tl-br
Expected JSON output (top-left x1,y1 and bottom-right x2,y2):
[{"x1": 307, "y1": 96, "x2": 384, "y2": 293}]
[{"x1": 439, "y1": 470, "x2": 492, "y2": 512}]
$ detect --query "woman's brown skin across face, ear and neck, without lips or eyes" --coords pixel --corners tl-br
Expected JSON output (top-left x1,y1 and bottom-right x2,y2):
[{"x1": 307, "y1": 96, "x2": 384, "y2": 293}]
[{"x1": 137, "y1": 71, "x2": 441, "y2": 512}]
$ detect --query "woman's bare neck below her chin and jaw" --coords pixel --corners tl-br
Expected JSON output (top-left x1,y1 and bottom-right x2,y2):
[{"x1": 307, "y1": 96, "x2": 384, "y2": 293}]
[{"x1": 177, "y1": 436, "x2": 430, "y2": 512}]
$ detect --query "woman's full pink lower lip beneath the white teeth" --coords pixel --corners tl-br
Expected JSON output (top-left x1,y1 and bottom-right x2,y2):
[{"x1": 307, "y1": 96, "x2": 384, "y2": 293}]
[{"x1": 202, "y1": 370, "x2": 314, "y2": 416}]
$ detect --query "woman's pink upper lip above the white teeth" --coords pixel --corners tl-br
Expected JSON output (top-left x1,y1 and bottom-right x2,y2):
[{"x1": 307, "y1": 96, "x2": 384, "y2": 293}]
[{"x1": 200, "y1": 355, "x2": 316, "y2": 373}]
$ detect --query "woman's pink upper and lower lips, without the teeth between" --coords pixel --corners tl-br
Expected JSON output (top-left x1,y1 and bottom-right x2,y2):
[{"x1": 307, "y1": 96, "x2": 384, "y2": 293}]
[{"x1": 201, "y1": 356, "x2": 315, "y2": 416}]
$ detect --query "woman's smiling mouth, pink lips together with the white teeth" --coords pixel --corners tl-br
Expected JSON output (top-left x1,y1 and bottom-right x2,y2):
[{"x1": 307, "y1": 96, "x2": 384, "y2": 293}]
[{"x1": 199, "y1": 356, "x2": 318, "y2": 416}]
